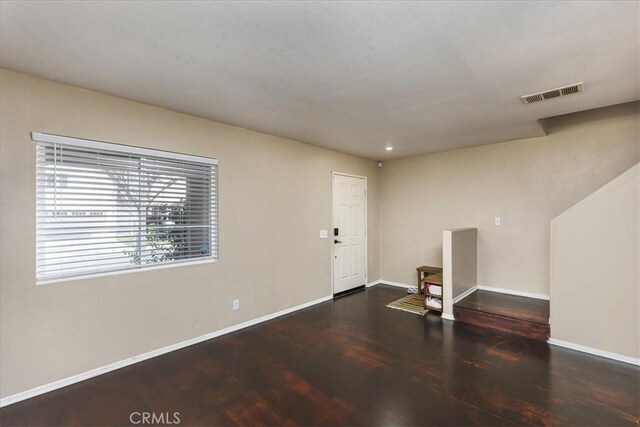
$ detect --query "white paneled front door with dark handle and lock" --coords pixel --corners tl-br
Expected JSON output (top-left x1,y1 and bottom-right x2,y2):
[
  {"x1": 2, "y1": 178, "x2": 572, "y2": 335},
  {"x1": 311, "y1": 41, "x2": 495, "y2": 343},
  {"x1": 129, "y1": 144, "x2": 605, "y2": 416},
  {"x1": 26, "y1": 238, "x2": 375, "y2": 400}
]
[{"x1": 332, "y1": 173, "x2": 367, "y2": 294}]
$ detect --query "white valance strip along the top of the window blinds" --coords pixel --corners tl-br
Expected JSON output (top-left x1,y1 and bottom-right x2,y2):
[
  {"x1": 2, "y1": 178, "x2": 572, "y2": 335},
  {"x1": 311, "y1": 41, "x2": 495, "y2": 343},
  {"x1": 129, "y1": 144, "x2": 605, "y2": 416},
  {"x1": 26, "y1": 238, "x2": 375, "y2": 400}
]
[{"x1": 31, "y1": 132, "x2": 218, "y2": 165}]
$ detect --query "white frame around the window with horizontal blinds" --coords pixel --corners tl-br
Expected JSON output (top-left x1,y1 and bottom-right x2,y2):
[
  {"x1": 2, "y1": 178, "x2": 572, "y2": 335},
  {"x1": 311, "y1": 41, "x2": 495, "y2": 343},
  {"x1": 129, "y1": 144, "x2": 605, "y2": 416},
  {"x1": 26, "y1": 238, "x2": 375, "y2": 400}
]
[{"x1": 31, "y1": 132, "x2": 220, "y2": 285}]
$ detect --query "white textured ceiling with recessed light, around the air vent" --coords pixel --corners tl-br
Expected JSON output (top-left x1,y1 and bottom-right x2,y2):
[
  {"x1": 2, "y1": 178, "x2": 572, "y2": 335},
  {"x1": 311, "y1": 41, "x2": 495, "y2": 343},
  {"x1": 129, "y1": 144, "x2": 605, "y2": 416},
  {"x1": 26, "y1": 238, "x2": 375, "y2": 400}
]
[{"x1": 0, "y1": 1, "x2": 640, "y2": 159}]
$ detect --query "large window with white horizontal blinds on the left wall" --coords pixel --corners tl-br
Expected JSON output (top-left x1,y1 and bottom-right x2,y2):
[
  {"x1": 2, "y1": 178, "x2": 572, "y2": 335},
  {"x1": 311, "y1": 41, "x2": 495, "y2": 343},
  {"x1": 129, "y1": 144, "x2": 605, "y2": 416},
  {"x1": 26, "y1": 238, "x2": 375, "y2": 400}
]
[{"x1": 32, "y1": 133, "x2": 218, "y2": 281}]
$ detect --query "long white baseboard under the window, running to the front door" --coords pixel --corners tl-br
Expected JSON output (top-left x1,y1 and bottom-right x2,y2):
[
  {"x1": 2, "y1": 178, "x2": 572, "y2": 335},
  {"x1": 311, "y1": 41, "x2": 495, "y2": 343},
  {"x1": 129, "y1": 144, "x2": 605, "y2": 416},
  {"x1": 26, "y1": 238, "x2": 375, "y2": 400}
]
[{"x1": 0, "y1": 295, "x2": 333, "y2": 408}]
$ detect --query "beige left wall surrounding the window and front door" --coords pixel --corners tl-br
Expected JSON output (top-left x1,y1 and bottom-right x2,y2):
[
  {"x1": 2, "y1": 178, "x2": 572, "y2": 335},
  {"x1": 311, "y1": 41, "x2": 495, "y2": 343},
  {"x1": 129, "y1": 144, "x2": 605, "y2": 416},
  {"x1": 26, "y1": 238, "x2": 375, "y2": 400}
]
[{"x1": 0, "y1": 70, "x2": 379, "y2": 397}]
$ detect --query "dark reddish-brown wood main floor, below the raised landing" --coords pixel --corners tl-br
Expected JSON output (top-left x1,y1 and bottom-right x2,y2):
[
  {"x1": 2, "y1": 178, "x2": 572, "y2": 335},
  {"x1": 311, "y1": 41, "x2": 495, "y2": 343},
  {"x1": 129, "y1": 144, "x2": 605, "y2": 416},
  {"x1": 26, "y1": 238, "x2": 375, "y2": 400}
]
[{"x1": 0, "y1": 285, "x2": 640, "y2": 426}]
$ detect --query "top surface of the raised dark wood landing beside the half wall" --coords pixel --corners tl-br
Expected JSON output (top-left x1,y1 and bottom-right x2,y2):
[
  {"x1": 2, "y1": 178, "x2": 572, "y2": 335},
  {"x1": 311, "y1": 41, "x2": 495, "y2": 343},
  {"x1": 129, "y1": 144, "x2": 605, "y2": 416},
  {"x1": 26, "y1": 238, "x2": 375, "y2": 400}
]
[{"x1": 455, "y1": 290, "x2": 549, "y2": 325}]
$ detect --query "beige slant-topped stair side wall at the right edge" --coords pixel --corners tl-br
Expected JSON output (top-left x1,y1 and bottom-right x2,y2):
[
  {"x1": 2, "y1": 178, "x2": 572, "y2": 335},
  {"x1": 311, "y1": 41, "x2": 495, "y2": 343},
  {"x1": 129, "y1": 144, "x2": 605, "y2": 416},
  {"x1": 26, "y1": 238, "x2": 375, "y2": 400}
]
[{"x1": 551, "y1": 165, "x2": 640, "y2": 359}]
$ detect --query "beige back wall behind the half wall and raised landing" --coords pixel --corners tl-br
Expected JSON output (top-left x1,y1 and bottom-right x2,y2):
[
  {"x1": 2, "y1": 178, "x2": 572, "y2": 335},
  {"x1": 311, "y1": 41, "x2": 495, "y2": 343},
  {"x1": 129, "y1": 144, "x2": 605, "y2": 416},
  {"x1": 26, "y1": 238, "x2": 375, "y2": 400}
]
[{"x1": 380, "y1": 102, "x2": 640, "y2": 295}]
